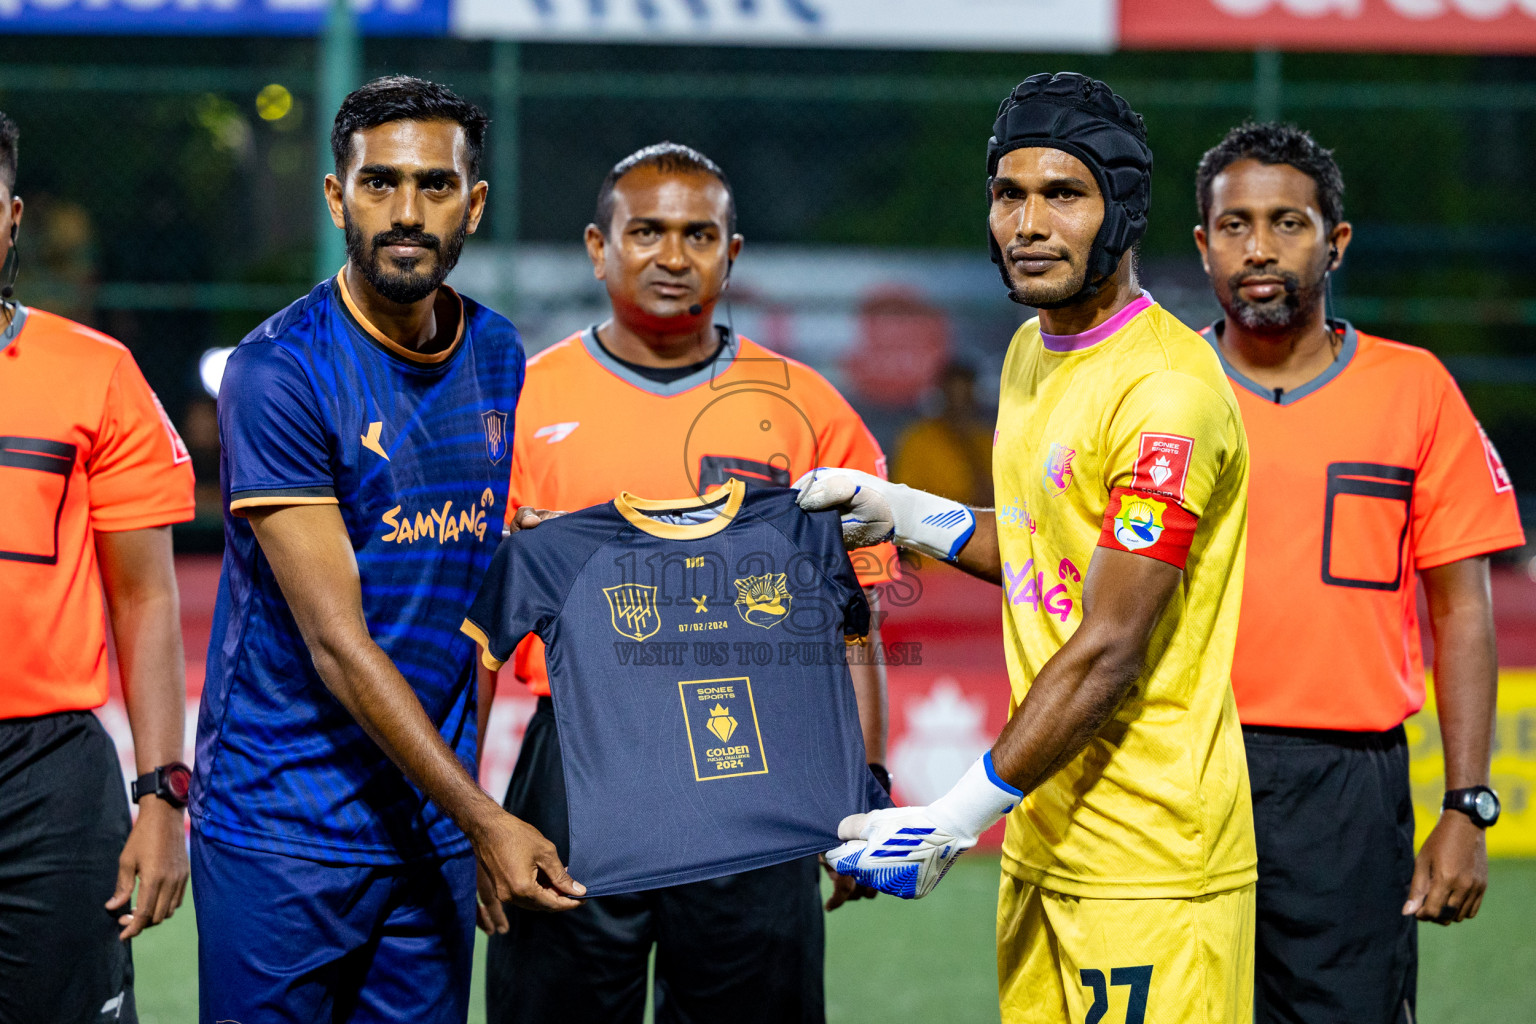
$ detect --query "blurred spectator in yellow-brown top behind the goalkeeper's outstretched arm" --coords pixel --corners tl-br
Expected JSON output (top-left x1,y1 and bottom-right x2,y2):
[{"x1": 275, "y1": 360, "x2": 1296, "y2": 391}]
[{"x1": 891, "y1": 362, "x2": 992, "y2": 508}]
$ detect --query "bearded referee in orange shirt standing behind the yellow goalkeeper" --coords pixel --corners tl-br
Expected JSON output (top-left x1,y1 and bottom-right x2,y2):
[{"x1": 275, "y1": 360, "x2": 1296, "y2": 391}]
[{"x1": 1195, "y1": 124, "x2": 1525, "y2": 1024}]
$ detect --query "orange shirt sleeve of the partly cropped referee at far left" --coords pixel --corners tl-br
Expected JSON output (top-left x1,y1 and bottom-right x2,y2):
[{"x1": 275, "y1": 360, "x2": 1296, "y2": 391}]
[{"x1": 86, "y1": 353, "x2": 194, "y2": 533}]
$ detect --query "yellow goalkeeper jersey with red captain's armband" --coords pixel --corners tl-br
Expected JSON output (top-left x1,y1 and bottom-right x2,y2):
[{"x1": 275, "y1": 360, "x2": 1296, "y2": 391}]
[{"x1": 992, "y1": 293, "x2": 1256, "y2": 900}]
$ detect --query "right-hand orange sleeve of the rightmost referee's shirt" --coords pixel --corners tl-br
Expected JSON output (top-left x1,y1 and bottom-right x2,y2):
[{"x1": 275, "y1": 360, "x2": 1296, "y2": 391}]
[{"x1": 1413, "y1": 362, "x2": 1525, "y2": 570}]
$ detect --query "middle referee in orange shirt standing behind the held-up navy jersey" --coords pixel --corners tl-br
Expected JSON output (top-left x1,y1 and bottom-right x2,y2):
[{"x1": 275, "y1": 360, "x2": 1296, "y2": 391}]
[{"x1": 481, "y1": 143, "x2": 895, "y2": 1024}]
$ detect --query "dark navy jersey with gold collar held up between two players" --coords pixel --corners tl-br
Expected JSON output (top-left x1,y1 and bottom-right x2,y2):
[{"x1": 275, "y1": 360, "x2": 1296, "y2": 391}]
[{"x1": 464, "y1": 479, "x2": 889, "y2": 895}]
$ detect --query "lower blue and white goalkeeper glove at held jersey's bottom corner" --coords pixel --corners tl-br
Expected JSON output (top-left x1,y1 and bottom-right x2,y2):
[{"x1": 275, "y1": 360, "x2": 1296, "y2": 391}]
[{"x1": 826, "y1": 751, "x2": 1023, "y2": 900}]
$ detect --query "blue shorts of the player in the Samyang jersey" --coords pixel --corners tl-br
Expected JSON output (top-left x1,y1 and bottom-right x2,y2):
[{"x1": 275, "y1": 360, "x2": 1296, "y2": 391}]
[{"x1": 192, "y1": 829, "x2": 475, "y2": 1024}]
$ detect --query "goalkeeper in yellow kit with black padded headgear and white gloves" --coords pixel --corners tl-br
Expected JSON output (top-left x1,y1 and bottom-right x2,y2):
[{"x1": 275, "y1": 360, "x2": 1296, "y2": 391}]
[{"x1": 800, "y1": 74, "x2": 1256, "y2": 1024}]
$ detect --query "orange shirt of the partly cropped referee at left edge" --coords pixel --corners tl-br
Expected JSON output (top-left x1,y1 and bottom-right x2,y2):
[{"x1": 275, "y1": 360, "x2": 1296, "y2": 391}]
[{"x1": 0, "y1": 306, "x2": 192, "y2": 718}]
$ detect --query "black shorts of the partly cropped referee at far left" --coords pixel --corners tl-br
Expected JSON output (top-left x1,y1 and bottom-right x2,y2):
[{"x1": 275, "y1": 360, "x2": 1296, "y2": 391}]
[{"x1": 0, "y1": 711, "x2": 138, "y2": 1024}]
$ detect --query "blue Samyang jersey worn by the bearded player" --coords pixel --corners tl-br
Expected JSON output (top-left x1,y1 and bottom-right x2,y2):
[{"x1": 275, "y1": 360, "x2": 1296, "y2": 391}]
[{"x1": 192, "y1": 276, "x2": 524, "y2": 864}]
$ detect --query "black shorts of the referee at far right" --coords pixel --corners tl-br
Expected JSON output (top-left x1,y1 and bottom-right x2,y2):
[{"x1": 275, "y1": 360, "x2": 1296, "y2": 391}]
[{"x1": 1243, "y1": 726, "x2": 1418, "y2": 1024}]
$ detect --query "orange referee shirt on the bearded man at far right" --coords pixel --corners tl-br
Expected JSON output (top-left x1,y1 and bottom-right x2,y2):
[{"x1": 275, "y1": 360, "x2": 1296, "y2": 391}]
[{"x1": 1204, "y1": 324, "x2": 1525, "y2": 731}]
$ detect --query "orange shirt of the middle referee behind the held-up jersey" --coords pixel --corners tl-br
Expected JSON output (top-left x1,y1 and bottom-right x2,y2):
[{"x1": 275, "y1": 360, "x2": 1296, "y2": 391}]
[{"x1": 507, "y1": 329, "x2": 899, "y2": 694}]
